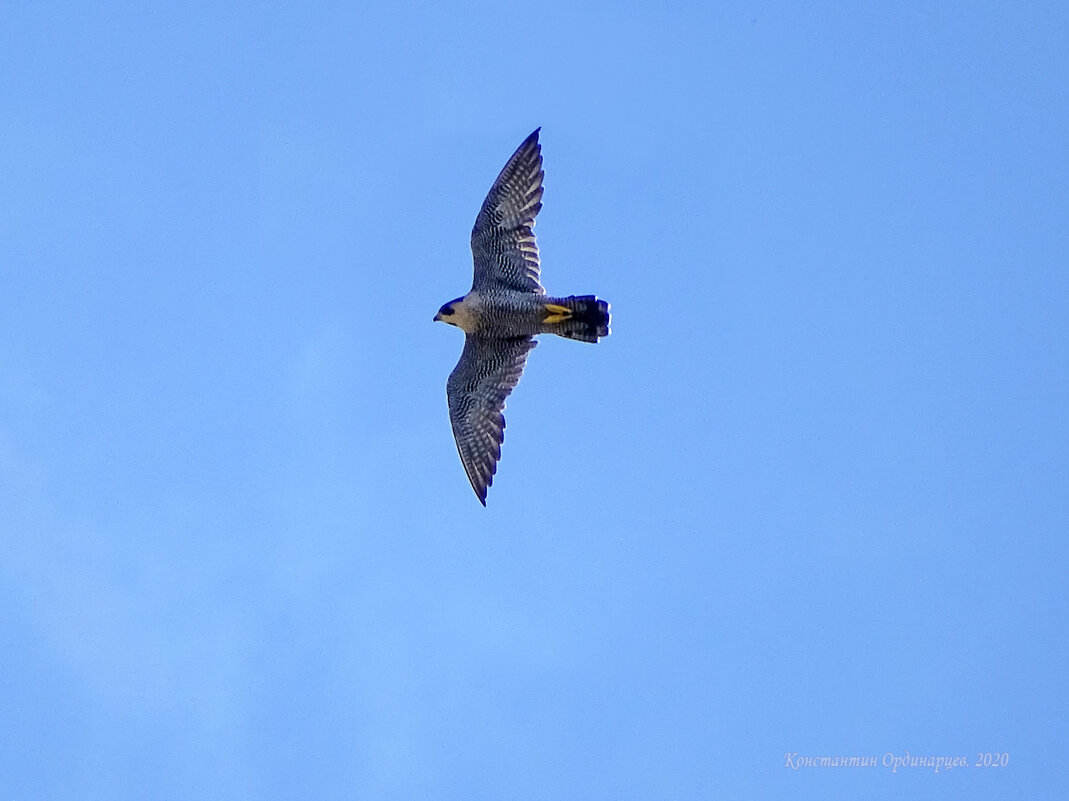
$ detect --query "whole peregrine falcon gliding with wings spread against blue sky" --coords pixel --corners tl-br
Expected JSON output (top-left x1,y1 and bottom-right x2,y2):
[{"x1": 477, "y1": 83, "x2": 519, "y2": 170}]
[{"x1": 434, "y1": 128, "x2": 609, "y2": 506}]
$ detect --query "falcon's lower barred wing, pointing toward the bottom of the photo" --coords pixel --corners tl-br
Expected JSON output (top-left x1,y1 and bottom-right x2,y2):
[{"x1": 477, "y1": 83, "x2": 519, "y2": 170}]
[{"x1": 446, "y1": 334, "x2": 537, "y2": 506}]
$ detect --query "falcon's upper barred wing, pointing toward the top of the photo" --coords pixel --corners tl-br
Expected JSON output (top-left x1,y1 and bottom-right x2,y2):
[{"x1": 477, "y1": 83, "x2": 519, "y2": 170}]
[{"x1": 471, "y1": 128, "x2": 545, "y2": 295}]
